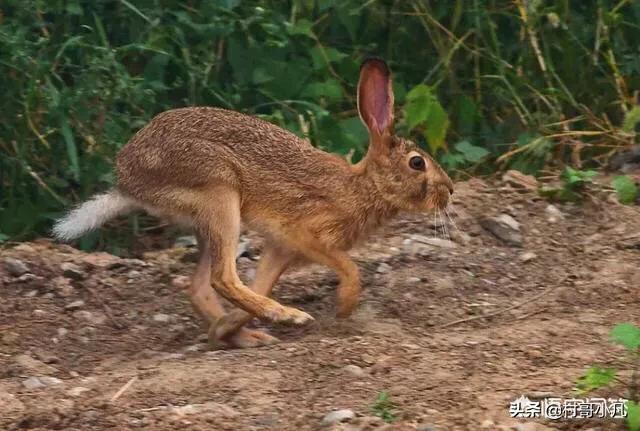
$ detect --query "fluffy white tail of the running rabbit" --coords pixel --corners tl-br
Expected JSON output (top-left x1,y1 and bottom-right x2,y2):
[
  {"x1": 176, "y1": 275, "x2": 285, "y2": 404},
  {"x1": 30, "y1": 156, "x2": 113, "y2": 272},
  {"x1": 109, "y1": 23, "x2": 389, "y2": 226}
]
[{"x1": 53, "y1": 190, "x2": 137, "y2": 241}]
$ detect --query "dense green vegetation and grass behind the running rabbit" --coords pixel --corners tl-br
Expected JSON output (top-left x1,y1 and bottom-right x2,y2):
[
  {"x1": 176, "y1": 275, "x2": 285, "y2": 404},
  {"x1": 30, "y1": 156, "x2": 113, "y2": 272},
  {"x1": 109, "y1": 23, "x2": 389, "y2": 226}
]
[{"x1": 0, "y1": 0, "x2": 640, "y2": 246}]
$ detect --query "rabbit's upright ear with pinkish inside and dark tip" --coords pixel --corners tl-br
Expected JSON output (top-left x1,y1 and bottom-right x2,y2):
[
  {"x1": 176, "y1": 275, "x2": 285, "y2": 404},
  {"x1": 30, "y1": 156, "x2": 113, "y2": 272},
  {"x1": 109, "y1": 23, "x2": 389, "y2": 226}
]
[{"x1": 358, "y1": 58, "x2": 393, "y2": 137}]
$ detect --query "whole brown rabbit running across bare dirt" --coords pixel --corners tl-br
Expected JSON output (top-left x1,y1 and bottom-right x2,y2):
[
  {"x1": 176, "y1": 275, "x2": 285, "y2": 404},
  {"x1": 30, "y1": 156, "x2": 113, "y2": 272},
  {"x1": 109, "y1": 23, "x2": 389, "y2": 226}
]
[{"x1": 54, "y1": 58, "x2": 453, "y2": 347}]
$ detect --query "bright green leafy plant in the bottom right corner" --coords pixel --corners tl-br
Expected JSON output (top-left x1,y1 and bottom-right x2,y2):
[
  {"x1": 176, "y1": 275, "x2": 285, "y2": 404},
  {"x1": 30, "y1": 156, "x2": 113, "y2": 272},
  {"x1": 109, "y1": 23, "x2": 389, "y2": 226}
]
[{"x1": 575, "y1": 323, "x2": 640, "y2": 431}]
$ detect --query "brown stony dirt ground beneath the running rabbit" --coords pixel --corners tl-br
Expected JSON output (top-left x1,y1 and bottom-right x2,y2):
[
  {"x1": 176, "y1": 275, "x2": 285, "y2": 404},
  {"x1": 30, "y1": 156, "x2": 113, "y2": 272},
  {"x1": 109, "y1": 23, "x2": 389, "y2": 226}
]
[{"x1": 0, "y1": 180, "x2": 640, "y2": 431}]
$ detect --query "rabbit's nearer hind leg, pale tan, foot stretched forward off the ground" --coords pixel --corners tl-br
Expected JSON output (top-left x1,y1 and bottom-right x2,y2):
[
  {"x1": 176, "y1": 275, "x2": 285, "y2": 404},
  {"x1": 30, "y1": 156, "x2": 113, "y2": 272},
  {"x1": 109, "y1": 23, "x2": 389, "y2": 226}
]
[{"x1": 195, "y1": 186, "x2": 313, "y2": 325}]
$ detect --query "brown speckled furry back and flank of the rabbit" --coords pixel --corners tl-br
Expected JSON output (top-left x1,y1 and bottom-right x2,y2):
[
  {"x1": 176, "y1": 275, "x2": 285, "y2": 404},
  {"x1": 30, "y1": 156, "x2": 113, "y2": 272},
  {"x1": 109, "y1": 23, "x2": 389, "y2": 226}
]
[{"x1": 116, "y1": 107, "x2": 360, "y2": 226}]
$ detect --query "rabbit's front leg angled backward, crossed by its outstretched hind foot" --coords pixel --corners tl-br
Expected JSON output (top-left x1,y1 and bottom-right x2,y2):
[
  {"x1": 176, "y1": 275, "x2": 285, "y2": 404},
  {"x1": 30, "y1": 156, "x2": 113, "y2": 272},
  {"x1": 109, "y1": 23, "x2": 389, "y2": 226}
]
[{"x1": 209, "y1": 244, "x2": 297, "y2": 339}]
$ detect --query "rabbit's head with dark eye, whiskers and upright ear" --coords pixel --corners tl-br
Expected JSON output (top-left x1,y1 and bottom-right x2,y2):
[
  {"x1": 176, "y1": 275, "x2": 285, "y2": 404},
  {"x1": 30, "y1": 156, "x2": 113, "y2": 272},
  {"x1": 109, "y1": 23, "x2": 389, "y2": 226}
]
[{"x1": 358, "y1": 58, "x2": 453, "y2": 211}]
